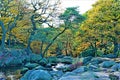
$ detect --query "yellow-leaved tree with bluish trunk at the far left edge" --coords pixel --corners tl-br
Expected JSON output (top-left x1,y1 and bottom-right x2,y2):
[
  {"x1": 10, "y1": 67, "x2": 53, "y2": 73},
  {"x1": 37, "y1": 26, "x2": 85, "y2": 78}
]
[{"x1": 0, "y1": 0, "x2": 20, "y2": 49}]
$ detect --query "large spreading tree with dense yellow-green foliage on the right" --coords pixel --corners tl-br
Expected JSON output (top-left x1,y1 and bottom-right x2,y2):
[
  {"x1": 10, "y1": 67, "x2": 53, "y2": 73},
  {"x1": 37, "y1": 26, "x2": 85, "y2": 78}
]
[{"x1": 78, "y1": 0, "x2": 120, "y2": 54}]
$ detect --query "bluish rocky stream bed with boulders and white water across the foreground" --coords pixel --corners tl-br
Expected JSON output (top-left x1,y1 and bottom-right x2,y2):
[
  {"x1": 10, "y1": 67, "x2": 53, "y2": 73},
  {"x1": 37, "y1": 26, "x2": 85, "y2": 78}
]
[{"x1": 0, "y1": 51, "x2": 120, "y2": 80}]
